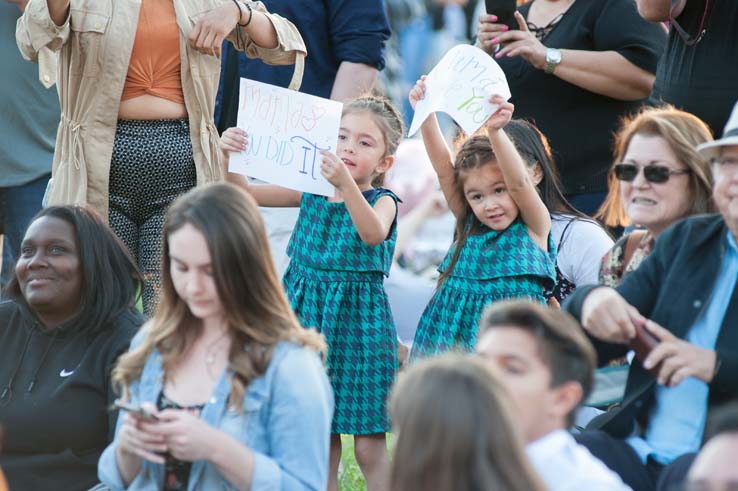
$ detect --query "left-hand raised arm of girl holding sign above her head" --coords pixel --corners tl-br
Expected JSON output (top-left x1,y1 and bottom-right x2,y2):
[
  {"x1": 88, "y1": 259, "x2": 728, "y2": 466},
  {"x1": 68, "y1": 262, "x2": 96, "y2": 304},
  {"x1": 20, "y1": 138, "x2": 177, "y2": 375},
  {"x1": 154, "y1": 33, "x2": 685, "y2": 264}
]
[{"x1": 409, "y1": 75, "x2": 464, "y2": 218}]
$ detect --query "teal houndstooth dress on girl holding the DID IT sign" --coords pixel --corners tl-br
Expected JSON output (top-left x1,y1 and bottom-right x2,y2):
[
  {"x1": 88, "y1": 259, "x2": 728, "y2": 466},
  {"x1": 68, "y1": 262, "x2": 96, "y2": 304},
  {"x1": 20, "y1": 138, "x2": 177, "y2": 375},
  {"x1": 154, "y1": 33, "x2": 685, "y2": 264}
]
[{"x1": 284, "y1": 188, "x2": 398, "y2": 435}]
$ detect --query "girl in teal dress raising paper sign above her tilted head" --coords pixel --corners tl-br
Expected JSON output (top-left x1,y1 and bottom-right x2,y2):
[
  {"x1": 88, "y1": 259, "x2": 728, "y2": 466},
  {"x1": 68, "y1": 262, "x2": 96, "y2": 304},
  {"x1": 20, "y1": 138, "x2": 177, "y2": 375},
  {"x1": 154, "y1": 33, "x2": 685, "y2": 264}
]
[{"x1": 410, "y1": 77, "x2": 556, "y2": 359}]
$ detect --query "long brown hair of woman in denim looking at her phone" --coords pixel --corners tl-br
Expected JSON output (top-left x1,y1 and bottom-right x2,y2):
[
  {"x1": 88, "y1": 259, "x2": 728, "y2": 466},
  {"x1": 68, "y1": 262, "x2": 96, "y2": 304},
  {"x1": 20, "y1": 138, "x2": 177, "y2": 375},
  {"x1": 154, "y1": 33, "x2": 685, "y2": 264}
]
[{"x1": 113, "y1": 183, "x2": 325, "y2": 410}]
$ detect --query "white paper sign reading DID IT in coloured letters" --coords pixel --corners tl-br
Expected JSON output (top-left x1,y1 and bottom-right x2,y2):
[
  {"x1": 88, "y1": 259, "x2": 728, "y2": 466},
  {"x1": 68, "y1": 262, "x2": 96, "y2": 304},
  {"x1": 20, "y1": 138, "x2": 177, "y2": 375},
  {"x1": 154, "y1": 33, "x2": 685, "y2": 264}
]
[{"x1": 228, "y1": 78, "x2": 343, "y2": 196}]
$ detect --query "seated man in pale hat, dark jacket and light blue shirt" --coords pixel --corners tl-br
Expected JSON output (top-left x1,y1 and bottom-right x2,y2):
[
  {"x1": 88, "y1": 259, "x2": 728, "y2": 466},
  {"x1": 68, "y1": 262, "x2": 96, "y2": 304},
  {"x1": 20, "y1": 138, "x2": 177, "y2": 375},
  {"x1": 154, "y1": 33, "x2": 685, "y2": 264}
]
[{"x1": 565, "y1": 104, "x2": 738, "y2": 491}]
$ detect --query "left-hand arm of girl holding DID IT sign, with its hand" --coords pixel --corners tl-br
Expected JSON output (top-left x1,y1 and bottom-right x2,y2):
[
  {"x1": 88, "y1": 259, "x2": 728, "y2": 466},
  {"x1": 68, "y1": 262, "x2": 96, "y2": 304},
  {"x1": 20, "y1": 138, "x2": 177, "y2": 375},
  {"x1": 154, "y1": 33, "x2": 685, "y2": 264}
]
[{"x1": 220, "y1": 127, "x2": 302, "y2": 208}]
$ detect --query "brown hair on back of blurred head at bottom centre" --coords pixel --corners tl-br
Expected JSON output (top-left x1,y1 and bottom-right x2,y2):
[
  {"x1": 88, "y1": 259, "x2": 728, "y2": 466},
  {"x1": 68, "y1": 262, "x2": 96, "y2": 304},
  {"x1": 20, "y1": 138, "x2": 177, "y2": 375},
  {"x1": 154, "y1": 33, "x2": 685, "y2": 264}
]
[{"x1": 390, "y1": 354, "x2": 543, "y2": 491}]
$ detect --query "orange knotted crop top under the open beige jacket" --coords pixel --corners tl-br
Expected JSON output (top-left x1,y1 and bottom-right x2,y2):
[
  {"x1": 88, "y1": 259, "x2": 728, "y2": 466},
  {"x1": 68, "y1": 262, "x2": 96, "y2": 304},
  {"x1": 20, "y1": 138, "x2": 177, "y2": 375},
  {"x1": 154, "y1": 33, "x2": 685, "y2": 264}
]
[{"x1": 121, "y1": 0, "x2": 184, "y2": 104}]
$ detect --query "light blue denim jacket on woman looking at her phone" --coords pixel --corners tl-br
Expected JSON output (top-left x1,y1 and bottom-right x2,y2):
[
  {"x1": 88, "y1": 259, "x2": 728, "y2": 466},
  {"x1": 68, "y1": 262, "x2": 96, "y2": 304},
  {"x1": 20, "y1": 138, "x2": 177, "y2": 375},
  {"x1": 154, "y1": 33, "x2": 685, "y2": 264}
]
[{"x1": 98, "y1": 329, "x2": 333, "y2": 491}]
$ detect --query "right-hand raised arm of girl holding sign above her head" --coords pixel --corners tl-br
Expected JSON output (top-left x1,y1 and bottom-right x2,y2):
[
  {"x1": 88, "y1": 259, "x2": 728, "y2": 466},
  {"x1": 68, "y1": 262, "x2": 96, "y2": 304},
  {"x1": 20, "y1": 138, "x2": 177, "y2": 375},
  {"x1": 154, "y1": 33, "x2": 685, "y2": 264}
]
[{"x1": 487, "y1": 95, "x2": 551, "y2": 251}]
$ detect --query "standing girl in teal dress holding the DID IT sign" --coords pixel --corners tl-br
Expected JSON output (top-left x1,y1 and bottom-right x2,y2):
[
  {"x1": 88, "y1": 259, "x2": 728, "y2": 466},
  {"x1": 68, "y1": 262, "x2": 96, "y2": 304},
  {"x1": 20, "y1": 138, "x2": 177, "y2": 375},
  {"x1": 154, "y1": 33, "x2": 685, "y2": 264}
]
[{"x1": 221, "y1": 97, "x2": 403, "y2": 490}]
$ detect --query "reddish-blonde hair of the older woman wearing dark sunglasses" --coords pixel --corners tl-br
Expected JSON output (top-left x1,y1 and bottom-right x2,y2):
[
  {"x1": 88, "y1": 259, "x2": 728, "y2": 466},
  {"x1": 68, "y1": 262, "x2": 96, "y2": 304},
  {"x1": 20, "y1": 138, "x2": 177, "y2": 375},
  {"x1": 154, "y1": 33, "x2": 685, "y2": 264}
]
[{"x1": 594, "y1": 105, "x2": 715, "y2": 227}]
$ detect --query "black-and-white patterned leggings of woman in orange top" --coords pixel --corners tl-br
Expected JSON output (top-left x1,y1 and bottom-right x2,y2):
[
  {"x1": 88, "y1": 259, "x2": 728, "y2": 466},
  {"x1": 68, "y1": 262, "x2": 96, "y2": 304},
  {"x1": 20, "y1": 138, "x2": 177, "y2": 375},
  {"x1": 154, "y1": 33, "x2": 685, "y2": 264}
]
[{"x1": 108, "y1": 119, "x2": 197, "y2": 316}]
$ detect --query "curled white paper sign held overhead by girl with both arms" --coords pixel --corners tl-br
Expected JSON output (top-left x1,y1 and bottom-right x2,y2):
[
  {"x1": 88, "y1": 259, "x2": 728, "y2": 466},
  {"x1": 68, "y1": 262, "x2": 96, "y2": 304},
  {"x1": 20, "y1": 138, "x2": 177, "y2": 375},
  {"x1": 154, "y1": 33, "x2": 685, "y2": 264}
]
[{"x1": 408, "y1": 44, "x2": 510, "y2": 136}]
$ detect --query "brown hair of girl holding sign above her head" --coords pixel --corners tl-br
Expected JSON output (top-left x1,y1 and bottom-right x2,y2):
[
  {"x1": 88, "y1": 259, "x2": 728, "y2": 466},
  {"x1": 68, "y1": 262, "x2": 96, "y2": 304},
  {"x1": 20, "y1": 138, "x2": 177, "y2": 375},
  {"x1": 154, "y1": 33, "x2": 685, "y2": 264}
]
[{"x1": 438, "y1": 133, "x2": 497, "y2": 285}]
